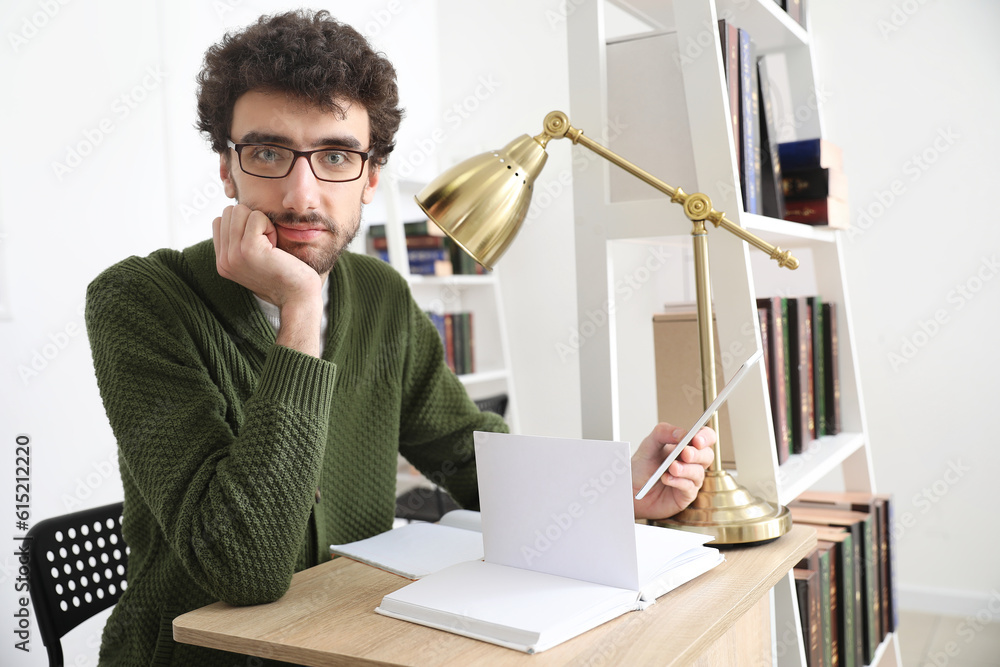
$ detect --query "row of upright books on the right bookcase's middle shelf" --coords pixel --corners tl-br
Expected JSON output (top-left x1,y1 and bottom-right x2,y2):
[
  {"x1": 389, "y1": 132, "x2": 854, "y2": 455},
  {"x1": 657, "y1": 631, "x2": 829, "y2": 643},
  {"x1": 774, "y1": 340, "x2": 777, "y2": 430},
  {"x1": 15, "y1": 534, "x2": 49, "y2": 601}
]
[{"x1": 757, "y1": 296, "x2": 841, "y2": 464}]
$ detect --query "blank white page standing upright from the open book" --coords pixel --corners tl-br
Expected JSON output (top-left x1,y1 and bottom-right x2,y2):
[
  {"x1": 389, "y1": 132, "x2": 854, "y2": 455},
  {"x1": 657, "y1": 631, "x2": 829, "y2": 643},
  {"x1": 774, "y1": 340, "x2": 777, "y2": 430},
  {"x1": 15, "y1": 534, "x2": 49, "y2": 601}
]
[{"x1": 475, "y1": 432, "x2": 639, "y2": 591}]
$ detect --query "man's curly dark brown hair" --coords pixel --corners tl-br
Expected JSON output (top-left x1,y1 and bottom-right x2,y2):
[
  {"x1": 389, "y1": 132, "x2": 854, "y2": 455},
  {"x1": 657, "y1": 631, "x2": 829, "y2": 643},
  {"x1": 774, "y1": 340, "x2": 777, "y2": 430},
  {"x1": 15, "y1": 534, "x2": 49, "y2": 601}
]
[{"x1": 197, "y1": 10, "x2": 403, "y2": 165}]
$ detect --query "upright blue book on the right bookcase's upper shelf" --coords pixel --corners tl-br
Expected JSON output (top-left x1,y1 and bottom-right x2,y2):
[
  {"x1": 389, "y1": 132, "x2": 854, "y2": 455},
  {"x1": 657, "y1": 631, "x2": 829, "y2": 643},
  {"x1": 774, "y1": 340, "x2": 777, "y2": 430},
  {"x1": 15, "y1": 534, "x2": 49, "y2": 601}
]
[{"x1": 738, "y1": 28, "x2": 763, "y2": 214}]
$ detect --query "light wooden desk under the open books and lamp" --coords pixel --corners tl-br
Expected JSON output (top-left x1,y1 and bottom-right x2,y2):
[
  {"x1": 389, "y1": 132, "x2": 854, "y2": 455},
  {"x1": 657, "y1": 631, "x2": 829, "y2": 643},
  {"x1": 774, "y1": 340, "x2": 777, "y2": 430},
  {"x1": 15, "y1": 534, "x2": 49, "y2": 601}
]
[{"x1": 174, "y1": 526, "x2": 816, "y2": 667}]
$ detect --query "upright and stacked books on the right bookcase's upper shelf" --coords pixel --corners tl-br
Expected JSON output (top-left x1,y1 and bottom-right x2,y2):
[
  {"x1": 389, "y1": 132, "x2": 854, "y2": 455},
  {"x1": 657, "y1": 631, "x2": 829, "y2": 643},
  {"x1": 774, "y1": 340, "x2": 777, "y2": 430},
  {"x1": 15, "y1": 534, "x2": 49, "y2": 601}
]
[{"x1": 719, "y1": 18, "x2": 850, "y2": 228}]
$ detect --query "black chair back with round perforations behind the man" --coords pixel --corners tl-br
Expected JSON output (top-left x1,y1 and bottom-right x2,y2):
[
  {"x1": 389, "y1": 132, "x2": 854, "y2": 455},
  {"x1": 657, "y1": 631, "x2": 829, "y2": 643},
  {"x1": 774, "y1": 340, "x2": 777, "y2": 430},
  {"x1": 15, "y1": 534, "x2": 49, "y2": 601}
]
[{"x1": 26, "y1": 503, "x2": 128, "y2": 667}]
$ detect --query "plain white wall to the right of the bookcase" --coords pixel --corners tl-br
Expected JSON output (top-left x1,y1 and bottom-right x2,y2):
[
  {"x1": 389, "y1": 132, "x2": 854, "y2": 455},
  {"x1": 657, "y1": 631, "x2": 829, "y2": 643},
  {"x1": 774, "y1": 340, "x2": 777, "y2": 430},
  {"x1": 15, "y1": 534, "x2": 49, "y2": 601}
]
[{"x1": 811, "y1": 0, "x2": 1000, "y2": 614}]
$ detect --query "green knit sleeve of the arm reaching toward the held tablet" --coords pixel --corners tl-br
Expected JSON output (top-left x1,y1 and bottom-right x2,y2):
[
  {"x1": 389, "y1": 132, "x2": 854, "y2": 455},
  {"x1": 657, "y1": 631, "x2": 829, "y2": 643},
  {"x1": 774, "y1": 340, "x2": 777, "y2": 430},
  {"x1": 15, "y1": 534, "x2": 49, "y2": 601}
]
[{"x1": 399, "y1": 294, "x2": 507, "y2": 509}]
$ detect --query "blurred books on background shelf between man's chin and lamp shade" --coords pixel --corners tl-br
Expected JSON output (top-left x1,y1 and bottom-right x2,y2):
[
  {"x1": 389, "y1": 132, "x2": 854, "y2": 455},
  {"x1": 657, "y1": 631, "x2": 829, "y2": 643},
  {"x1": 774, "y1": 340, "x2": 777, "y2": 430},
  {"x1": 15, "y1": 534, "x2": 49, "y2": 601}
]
[{"x1": 367, "y1": 220, "x2": 486, "y2": 276}]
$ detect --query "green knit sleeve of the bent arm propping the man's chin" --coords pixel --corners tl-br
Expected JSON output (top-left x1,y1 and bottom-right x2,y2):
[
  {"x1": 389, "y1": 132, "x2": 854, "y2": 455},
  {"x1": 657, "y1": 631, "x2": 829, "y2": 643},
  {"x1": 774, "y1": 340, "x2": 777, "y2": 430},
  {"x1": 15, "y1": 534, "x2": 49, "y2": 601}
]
[{"x1": 86, "y1": 264, "x2": 336, "y2": 605}]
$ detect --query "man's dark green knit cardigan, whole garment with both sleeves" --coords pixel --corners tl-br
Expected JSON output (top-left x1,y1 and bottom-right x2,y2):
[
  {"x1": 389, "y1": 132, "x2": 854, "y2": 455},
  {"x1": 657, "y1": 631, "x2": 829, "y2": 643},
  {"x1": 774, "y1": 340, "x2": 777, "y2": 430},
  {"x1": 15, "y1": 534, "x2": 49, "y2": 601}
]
[{"x1": 86, "y1": 241, "x2": 506, "y2": 667}]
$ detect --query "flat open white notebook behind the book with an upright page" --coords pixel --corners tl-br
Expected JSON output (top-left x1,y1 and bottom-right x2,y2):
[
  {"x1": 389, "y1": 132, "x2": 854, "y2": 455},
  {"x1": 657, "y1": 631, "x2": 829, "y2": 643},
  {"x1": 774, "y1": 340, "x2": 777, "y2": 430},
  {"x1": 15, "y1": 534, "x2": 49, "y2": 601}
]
[{"x1": 330, "y1": 509, "x2": 483, "y2": 579}]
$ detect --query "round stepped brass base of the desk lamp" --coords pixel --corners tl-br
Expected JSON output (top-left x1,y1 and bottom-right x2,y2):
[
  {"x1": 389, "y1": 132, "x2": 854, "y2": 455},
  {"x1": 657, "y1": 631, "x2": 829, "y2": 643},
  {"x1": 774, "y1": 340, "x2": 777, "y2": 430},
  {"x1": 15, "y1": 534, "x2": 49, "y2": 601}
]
[{"x1": 653, "y1": 470, "x2": 792, "y2": 546}]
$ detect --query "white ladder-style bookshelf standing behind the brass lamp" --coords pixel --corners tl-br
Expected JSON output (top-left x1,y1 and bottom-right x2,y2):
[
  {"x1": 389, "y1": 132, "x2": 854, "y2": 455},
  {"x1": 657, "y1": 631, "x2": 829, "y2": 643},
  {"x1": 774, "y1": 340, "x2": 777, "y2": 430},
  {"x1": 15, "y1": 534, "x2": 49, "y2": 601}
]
[{"x1": 568, "y1": 0, "x2": 901, "y2": 667}]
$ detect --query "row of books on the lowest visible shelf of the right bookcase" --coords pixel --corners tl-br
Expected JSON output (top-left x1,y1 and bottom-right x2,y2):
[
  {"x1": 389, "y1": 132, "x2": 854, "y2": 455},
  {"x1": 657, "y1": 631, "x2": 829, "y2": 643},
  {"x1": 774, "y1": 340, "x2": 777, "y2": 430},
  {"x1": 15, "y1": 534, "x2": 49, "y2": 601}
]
[{"x1": 789, "y1": 491, "x2": 898, "y2": 667}]
